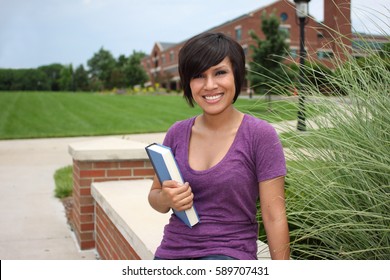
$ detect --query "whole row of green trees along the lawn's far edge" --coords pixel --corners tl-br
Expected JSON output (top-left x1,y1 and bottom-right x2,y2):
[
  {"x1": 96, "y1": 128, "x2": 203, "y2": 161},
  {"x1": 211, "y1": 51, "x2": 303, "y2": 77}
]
[{"x1": 0, "y1": 48, "x2": 148, "y2": 91}]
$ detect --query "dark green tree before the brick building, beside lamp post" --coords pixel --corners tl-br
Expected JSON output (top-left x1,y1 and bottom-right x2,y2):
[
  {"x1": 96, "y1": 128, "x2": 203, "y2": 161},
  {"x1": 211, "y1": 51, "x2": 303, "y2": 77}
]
[{"x1": 248, "y1": 12, "x2": 289, "y2": 93}]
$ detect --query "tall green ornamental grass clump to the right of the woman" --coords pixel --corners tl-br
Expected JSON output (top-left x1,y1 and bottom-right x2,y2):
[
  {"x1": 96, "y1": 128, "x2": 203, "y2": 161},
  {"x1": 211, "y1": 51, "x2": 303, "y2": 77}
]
[{"x1": 276, "y1": 38, "x2": 390, "y2": 260}]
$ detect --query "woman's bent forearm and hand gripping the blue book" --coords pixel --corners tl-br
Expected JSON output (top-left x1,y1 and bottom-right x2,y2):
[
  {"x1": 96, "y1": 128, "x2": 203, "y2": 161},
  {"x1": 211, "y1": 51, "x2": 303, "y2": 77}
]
[{"x1": 148, "y1": 176, "x2": 194, "y2": 213}]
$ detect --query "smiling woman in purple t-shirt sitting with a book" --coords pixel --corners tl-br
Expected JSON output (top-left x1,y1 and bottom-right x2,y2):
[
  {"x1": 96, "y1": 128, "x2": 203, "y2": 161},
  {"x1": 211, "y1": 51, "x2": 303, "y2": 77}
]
[{"x1": 149, "y1": 33, "x2": 290, "y2": 259}]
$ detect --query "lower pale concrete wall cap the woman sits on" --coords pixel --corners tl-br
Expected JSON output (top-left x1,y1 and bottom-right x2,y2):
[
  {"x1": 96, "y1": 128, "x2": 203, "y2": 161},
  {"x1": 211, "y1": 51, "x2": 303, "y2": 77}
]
[{"x1": 91, "y1": 180, "x2": 171, "y2": 260}]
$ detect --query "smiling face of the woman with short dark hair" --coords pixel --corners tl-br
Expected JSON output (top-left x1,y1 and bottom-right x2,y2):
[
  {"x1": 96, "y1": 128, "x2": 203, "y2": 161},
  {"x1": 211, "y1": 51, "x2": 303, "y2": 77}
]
[{"x1": 190, "y1": 57, "x2": 236, "y2": 115}]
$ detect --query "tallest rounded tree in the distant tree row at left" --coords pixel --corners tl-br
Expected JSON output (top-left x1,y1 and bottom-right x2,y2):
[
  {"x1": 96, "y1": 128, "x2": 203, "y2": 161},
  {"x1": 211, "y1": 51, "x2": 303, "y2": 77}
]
[{"x1": 87, "y1": 47, "x2": 116, "y2": 88}]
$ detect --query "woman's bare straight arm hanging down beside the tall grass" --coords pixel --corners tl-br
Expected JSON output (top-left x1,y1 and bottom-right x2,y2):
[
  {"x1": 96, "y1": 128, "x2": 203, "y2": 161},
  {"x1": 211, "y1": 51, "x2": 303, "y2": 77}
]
[{"x1": 259, "y1": 177, "x2": 290, "y2": 260}]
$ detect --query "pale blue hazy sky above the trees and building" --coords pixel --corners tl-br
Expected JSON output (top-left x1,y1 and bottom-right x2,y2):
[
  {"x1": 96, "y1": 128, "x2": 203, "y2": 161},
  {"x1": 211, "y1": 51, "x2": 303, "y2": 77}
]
[{"x1": 0, "y1": 0, "x2": 390, "y2": 68}]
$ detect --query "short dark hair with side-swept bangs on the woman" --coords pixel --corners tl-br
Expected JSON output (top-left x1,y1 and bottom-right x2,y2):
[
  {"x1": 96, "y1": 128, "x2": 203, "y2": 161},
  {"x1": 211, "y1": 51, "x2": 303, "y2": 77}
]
[{"x1": 179, "y1": 33, "x2": 245, "y2": 107}]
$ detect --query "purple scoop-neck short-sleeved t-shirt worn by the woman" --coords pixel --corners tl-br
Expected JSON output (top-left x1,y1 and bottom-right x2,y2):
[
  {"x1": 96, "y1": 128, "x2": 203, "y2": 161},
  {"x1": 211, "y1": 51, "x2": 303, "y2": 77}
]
[{"x1": 156, "y1": 115, "x2": 286, "y2": 259}]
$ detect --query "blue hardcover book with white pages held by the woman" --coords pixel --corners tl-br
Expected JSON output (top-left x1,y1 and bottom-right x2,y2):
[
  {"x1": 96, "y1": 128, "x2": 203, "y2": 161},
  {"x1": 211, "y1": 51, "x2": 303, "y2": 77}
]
[{"x1": 145, "y1": 143, "x2": 199, "y2": 228}]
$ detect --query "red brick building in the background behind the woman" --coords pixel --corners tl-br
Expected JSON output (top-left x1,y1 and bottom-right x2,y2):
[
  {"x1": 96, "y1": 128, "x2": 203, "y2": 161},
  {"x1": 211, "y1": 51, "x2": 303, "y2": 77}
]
[{"x1": 141, "y1": 0, "x2": 388, "y2": 90}]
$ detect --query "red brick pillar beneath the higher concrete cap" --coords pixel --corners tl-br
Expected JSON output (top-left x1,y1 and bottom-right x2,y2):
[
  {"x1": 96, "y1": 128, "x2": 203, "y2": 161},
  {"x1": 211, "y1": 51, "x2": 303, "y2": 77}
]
[{"x1": 72, "y1": 159, "x2": 154, "y2": 249}]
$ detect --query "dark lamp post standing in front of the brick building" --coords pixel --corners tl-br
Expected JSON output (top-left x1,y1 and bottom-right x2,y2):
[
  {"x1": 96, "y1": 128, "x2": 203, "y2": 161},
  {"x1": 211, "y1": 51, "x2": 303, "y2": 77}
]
[{"x1": 294, "y1": 0, "x2": 310, "y2": 131}]
